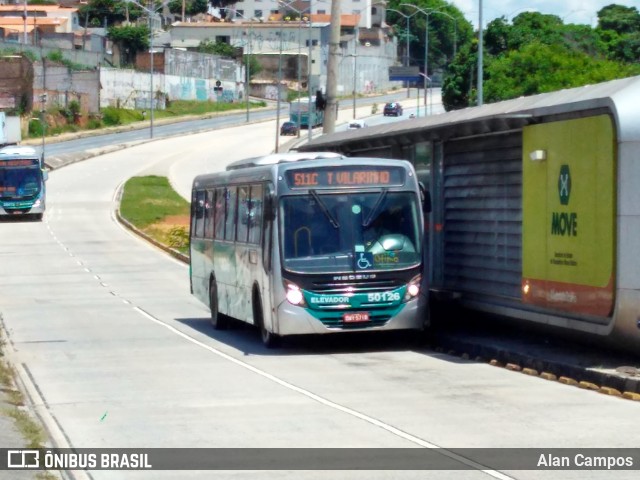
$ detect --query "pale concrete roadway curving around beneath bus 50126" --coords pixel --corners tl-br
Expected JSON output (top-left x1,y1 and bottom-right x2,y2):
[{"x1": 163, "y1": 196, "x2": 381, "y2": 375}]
[{"x1": 0, "y1": 114, "x2": 640, "y2": 480}]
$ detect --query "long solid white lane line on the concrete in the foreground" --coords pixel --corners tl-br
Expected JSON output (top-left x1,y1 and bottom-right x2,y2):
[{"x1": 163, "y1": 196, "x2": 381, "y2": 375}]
[{"x1": 133, "y1": 307, "x2": 514, "y2": 480}]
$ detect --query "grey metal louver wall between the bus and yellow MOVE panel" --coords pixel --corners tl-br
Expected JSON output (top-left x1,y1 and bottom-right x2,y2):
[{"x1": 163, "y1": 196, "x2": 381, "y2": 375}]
[{"x1": 442, "y1": 132, "x2": 522, "y2": 298}]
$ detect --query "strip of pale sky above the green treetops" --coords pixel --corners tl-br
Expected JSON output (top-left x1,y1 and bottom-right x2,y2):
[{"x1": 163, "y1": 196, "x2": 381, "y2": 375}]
[{"x1": 449, "y1": 0, "x2": 640, "y2": 28}]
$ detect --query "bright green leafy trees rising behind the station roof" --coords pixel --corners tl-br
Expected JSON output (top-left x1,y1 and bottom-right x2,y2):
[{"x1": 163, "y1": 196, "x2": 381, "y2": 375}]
[{"x1": 442, "y1": 5, "x2": 640, "y2": 110}]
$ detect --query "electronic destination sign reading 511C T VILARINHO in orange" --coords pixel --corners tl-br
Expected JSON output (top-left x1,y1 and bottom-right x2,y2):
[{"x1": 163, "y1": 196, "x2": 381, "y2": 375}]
[{"x1": 287, "y1": 166, "x2": 404, "y2": 188}]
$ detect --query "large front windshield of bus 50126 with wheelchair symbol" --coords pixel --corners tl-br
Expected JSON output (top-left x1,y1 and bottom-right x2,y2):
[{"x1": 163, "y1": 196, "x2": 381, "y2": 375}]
[{"x1": 280, "y1": 189, "x2": 422, "y2": 273}]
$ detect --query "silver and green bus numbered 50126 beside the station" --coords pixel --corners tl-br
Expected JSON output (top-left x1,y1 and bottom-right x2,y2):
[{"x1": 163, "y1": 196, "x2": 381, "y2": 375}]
[{"x1": 190, "y1": 152, "x2": 428, "y2": 346}]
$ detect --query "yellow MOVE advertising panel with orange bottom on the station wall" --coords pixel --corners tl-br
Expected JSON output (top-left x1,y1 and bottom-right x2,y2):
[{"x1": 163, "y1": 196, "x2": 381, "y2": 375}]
[{"x1": 522, "y1": 115, "x2": 616, "y2": 317}]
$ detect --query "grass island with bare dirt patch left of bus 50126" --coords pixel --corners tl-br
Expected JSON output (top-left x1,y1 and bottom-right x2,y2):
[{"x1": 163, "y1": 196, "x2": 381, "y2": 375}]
[{"x1": 120, "y1": 175, "x2": 190, "y2": 254}]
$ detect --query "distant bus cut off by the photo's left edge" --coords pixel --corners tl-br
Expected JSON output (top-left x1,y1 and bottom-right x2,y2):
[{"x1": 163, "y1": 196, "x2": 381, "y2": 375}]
[{"x1": 0, "y1": 146, "x2": 47, "y2": 220}]
